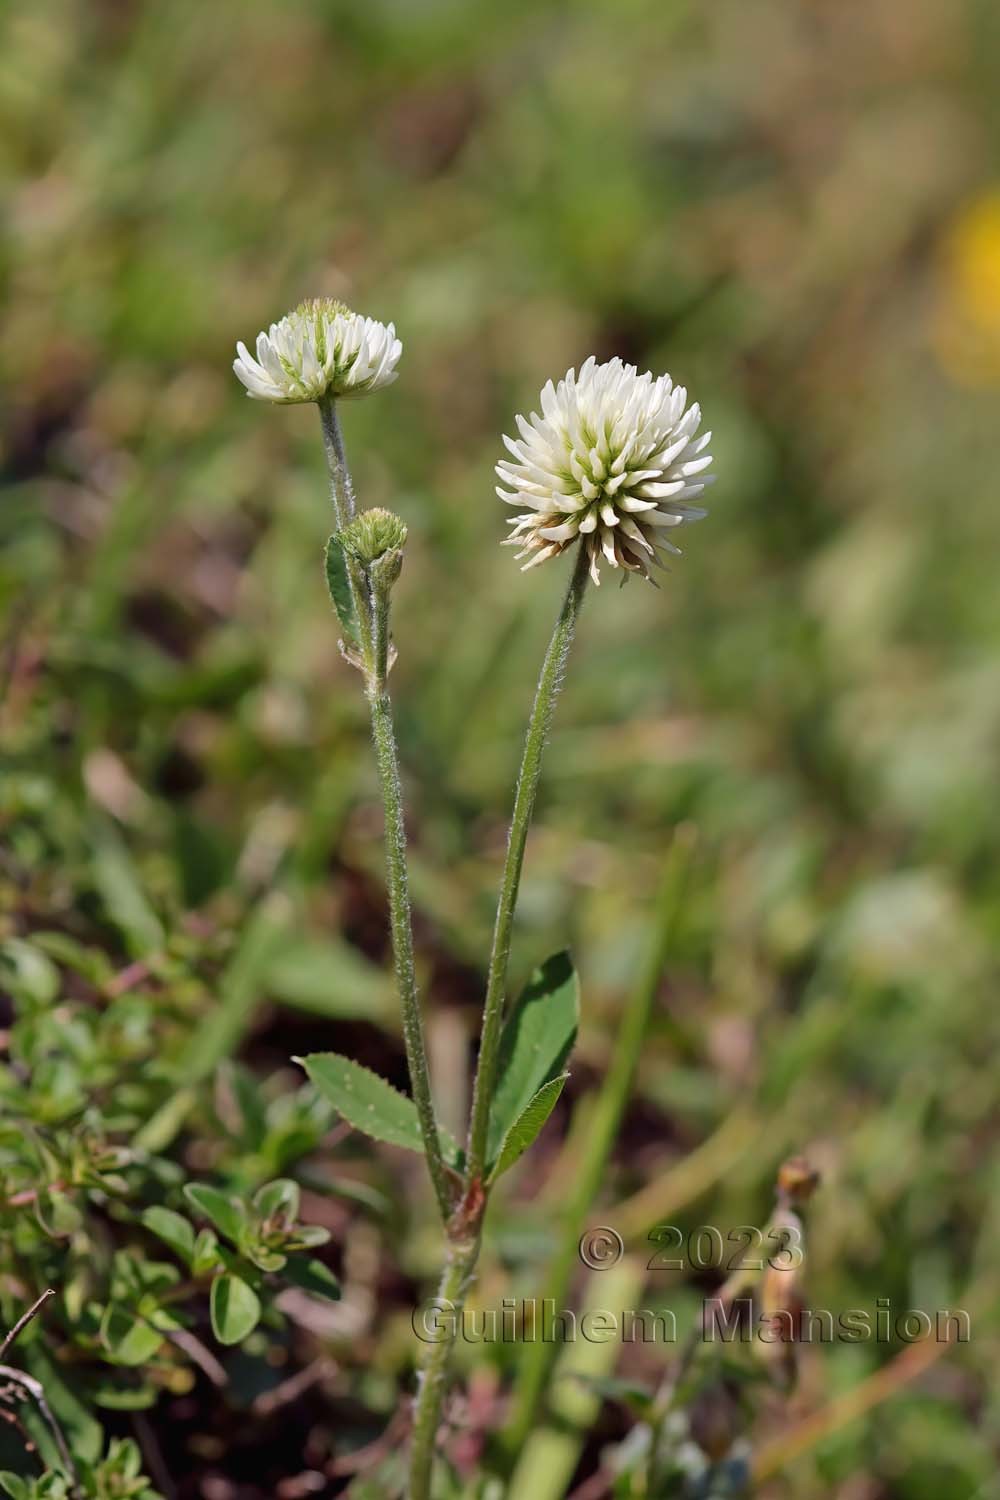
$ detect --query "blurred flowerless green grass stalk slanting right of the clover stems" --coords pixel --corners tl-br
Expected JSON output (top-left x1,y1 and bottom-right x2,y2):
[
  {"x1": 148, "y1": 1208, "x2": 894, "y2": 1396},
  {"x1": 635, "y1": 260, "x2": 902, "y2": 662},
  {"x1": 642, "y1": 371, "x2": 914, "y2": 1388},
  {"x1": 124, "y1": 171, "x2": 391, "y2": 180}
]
[{"x1": 501, "y1": 825, "x2": 694, "y2": 1461}]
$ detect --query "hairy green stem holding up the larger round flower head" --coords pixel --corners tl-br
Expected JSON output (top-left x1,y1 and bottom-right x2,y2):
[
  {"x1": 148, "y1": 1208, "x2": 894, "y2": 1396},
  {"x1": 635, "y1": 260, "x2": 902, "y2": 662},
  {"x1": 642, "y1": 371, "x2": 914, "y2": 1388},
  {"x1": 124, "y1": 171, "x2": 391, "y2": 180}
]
[{"x1": 466, "y1": 546, "x2": 588, "y2": 1194}]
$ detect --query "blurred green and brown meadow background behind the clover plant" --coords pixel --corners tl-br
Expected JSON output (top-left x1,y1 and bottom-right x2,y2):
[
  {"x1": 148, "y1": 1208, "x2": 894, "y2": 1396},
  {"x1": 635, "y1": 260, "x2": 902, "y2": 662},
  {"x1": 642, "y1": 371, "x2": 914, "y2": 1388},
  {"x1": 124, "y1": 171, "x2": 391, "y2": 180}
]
[{"x1": 0, "y1": 0, "x2": 1000, "y2": 1500}]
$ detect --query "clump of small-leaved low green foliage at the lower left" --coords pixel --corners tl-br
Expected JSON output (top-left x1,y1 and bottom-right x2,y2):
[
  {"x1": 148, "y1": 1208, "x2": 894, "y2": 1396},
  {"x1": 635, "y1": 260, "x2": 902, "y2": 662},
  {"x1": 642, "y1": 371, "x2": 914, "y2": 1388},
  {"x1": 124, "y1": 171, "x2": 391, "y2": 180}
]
[{"x1": 0, "y1": 933, "x2": 339, "y2": 1500}]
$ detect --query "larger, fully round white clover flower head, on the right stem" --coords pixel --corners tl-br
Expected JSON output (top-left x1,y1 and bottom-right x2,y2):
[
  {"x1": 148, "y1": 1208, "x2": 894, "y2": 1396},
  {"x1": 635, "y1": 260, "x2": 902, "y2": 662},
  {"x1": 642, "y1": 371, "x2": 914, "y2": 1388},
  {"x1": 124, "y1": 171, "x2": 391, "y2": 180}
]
[{"x1": 496, "y1": 356, "x2": 714, "y2": 584}]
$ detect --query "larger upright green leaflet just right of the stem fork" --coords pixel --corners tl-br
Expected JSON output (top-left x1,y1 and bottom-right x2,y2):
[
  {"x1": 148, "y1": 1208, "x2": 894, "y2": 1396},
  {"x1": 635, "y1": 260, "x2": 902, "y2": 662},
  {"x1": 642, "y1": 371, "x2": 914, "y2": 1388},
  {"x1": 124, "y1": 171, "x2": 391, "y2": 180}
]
[{"x1": 486, "y1": 953, "x2": 580, "y2": 1163}]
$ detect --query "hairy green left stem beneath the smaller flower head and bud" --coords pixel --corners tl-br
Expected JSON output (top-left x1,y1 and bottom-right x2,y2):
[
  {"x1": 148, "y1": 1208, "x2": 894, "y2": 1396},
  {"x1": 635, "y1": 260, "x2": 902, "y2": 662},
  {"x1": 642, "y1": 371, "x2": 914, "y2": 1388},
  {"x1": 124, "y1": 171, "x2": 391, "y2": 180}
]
[{"x1": 318, "y1": 398, "x2": 453, "y2": 1221}]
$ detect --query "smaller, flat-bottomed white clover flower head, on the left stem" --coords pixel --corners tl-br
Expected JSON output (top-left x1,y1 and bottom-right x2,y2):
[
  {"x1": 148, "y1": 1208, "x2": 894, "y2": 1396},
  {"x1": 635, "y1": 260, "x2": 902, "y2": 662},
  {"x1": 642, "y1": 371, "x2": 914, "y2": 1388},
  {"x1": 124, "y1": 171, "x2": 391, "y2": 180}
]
[{"x1": 232, "y1": 297, "x2": 403, "y2": 402}]
